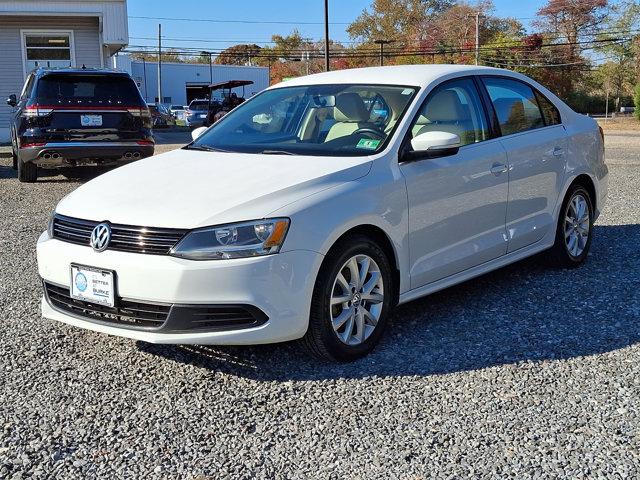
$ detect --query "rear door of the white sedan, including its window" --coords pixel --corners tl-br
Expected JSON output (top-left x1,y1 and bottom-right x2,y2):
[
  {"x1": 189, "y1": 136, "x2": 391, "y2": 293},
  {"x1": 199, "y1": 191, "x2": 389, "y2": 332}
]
[{"x1": 482, "y1": 76, "x2": 567, "y2": 252}]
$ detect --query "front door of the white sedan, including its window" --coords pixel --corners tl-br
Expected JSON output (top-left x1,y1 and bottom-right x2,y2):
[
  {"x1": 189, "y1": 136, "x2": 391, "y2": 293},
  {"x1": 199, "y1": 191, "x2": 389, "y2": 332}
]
[{"x1": 400, "y1": 77, "x2": 508, "y2": 288}]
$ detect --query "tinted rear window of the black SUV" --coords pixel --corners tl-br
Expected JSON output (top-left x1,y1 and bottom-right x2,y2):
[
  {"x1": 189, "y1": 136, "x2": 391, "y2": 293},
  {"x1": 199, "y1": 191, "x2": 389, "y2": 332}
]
[{"x1": 36, "y1": 75, "x2": 142, "y2": 106}]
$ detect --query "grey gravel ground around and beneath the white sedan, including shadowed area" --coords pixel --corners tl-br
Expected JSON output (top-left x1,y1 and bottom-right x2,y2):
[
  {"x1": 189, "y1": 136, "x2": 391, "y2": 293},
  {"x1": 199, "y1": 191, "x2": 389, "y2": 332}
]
[{"x1": 0, "y1": 132, "x2": 640, "y2": 480}]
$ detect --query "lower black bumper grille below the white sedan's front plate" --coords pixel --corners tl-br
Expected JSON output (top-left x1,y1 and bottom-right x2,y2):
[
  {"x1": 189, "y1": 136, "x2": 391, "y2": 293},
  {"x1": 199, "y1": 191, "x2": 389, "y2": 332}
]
[{"x1": 44, "y1": 282, "x2": 171, "y2": 328}]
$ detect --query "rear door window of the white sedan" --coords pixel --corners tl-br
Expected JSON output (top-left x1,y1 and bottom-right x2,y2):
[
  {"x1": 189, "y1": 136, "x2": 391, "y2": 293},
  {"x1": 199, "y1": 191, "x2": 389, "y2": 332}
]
[{"x1": 482, "y1": 77, "x2": 545, "y2": 135}]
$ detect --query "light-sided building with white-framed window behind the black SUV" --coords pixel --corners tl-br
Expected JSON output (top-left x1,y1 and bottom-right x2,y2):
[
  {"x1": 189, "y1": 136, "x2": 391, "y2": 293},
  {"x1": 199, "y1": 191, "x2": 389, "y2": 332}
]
[{"x1": 0, "y1": 0, "x2": 129, "y2": 142}]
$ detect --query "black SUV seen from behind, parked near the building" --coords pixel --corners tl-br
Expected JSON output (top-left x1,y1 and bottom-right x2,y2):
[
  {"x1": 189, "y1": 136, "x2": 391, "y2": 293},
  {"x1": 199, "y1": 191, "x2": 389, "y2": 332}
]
[{"x1": 7, "y1": 67, "x2": 154, "y2": 182}]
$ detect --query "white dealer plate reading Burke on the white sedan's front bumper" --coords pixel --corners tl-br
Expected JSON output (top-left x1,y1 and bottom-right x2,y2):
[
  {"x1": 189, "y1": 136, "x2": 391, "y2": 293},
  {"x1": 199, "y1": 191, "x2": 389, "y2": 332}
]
[{"x1": 70, "y1": 263, "x2": 115, "y2": 307}]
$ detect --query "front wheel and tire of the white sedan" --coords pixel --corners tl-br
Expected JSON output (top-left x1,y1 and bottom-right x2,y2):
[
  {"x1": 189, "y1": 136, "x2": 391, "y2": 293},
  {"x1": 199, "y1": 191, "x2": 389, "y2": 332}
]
[{"x1": 302, "y1": 235, "x2": 395, "y2": 362}]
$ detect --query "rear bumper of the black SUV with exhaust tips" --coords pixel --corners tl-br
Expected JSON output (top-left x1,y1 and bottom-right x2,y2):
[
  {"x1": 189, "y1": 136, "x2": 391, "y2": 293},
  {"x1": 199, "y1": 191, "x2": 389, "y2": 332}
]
[{"x1": 20, "y1": 141, "x2": 155, "y2": 168}]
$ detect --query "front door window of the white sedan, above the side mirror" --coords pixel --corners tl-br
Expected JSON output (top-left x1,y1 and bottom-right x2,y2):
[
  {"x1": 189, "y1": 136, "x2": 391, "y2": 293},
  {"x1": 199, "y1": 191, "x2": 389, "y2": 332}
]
[{"x1": 411, "y1": 79, "x2": 489, "y2": 145}]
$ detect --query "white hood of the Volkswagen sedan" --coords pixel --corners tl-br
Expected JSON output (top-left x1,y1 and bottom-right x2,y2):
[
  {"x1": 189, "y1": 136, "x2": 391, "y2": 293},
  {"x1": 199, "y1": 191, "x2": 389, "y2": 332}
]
[{"x1": 56, "y1": 150, "x2": 371, "y2": 228}]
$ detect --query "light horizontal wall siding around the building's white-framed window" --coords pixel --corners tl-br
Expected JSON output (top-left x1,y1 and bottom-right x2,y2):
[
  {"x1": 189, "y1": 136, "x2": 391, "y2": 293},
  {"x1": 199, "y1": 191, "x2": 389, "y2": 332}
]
[{"x1": 0, "y1": 15, "x2": 101, "y2": 142}]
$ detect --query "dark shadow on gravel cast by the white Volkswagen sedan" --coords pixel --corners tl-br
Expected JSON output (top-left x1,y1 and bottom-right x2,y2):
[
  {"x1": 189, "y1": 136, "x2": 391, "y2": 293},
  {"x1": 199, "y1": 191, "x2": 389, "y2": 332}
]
[{"x1": 138, "y1": 224, "x2": 640, "y2": 380}]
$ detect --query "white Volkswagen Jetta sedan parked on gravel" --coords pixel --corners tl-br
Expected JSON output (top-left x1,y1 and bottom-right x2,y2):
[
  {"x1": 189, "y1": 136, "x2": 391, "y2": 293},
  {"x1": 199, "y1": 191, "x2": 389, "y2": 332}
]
[{"x1": 38, "y1": 65, "x2": 607, "y2": 361}]
